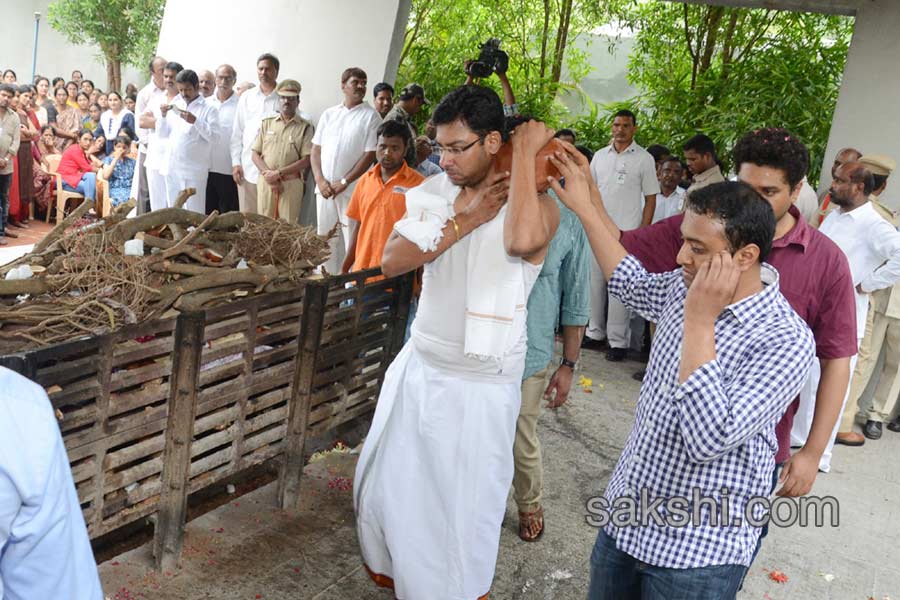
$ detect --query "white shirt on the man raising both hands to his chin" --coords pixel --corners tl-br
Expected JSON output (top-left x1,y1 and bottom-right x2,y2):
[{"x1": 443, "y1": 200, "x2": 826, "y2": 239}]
[{"x1": 157, "y1": 94, "x2": 219, "y2": 178}]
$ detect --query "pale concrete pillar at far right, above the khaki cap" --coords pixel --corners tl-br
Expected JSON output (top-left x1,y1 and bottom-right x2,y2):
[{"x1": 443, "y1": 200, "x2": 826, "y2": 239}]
[{"x1": 819, "y1": 0, "x2": 900, "y2": 210}]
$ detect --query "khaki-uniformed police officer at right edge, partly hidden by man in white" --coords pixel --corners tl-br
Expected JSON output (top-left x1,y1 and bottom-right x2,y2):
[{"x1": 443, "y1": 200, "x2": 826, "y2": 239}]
[{"x1": 835, "y1": 154, "x2": 900, "y2": 446}]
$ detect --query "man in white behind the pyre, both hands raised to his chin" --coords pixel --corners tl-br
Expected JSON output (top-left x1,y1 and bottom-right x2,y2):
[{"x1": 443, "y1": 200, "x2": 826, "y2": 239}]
[{"x1": 157, "y1": 69, "x2": 219, "y2": 213}]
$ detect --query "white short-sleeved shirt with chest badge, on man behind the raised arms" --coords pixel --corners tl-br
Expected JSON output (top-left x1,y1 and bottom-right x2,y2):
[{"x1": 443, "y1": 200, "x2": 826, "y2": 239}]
[{"x1": 591, "y1": 141, "x2": 659, "y2": 230}]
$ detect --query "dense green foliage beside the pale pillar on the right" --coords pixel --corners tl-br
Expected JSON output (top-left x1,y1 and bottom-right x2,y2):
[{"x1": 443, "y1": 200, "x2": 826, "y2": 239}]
[{"x1": 602, "y1": 2, "x2": 852, "y2": 185}]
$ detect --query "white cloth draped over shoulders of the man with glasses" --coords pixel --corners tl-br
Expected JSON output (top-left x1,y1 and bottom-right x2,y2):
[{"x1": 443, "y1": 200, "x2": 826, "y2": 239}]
[{"x1": 394, "y1": 173, "x2": 525, "y2": 361}]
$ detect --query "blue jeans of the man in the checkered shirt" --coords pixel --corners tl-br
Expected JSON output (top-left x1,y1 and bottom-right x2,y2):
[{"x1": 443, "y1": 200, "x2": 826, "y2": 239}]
[{"x1": 588, "y1": 529, "x2": 747, "y2": 600}]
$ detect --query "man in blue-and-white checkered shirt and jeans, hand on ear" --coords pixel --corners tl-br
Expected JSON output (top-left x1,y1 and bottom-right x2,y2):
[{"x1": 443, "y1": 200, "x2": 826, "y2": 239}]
[{"x1": 552, "y1": 149, "x2": 815, "y2": 600}]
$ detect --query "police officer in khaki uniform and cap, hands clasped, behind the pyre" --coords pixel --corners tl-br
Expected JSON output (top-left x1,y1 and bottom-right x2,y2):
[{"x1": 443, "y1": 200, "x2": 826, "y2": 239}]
[{"x1": 252, "y1": 79, "x2": 314, "y2": 223}]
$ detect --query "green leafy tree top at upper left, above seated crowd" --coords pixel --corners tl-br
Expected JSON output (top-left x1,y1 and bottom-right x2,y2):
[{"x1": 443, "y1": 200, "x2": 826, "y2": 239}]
[{"x1": 48, "y1": 0, "x2": 166, "y2": 84}]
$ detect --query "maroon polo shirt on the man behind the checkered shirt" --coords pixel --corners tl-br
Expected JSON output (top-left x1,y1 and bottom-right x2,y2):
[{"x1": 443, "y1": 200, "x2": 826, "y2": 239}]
[{"x1": 621, "y1": 206, "x2": 857, "y2": 464}]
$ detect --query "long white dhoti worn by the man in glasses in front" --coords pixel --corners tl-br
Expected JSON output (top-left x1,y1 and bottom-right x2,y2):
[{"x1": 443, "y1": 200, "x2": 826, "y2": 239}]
[{"x1": 354, "y1": 340, "x2": 521, "y2": 600}]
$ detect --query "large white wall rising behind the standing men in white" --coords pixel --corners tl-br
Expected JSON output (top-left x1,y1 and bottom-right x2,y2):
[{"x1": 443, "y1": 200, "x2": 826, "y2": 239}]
[{"x1": 159, "y1": 0, "x2": 410, "y2": 120}]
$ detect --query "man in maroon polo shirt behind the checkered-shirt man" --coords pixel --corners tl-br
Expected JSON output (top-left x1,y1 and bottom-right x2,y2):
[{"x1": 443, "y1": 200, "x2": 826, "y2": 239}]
[{"x1": 602, "y1": 129, "x2": 856, "y2": 497}]
